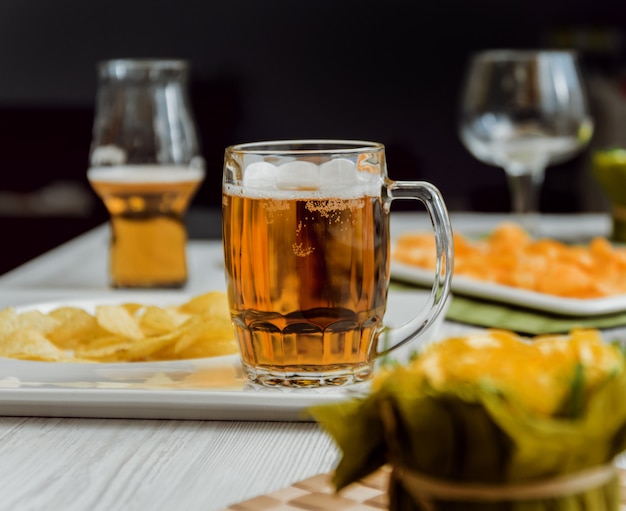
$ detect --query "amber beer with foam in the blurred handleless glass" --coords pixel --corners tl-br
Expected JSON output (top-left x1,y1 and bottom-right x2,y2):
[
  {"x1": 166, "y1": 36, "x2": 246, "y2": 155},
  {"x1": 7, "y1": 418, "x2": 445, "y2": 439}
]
[{"x1": 87, "y1": 165, "x2": 204, "y2": 288}]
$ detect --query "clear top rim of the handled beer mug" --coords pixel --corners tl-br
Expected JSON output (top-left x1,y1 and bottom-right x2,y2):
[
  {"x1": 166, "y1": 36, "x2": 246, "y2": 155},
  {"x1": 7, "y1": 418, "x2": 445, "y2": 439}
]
[{"x1": 226, "y1": 138, "x2": 385, "y2": 155}]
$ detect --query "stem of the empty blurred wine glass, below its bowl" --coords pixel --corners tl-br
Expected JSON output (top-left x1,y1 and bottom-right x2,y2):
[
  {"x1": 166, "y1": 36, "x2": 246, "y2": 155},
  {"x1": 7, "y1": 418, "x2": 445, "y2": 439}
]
[{"x1": 505, "y1": 168, "x2": 545, "y2": 236}]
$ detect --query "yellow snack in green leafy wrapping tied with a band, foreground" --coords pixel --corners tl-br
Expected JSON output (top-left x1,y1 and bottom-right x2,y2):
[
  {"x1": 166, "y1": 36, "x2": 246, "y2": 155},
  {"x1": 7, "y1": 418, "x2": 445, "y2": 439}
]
[{"x1": 309, "y1": 330, "x2": 626, "y2": 511}]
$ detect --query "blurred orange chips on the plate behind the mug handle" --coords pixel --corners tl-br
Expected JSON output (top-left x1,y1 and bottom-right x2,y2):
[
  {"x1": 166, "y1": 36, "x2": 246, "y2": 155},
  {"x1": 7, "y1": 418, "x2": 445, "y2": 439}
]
[{"x1": 393, "y1": 223, "x2": 626, "y2": 299}]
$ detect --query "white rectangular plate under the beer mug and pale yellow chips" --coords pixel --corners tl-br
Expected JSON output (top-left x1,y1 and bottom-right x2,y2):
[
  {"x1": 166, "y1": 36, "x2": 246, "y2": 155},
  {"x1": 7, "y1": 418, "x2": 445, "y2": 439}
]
[{"x1": 0, "y1": 292, "x2": 443, "y2": 421}]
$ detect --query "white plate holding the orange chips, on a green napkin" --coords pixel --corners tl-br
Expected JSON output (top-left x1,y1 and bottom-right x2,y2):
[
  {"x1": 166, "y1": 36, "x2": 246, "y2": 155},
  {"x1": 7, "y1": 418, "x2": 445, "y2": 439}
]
[{"x1": 391, "y1": 260, "x2": 626, "y2": 316}]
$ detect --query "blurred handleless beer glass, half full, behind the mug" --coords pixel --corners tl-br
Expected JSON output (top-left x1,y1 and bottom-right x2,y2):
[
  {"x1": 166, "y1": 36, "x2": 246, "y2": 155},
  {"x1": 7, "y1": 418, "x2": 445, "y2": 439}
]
[{"x1": 87, "y1": 60, "x2": 204, "y2": 288}]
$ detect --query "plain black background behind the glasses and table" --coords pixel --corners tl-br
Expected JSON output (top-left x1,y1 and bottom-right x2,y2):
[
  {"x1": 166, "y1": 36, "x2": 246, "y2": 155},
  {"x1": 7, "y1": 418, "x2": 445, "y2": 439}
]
[{"x1": 0, "y1": 0, "x2": 626, "y2": 273}]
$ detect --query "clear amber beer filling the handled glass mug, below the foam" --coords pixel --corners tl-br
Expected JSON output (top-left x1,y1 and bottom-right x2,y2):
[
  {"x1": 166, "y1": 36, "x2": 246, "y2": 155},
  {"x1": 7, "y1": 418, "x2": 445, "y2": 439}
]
[{"x1": 223, "y1": 186, "x2": 389, "y2": 386}]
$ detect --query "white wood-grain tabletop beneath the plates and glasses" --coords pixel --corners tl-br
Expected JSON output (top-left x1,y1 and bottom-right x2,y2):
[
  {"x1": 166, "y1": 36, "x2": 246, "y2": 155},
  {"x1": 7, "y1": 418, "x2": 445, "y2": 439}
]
[{"x1": 0, "y1": 213, "x2": 610, "y2": 511}]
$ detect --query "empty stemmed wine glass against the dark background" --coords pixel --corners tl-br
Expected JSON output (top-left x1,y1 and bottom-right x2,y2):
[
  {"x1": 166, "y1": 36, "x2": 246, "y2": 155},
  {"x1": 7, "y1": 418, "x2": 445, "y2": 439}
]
[{"x1": 459, "y1": 50, "x2": 593, "y2": 235}]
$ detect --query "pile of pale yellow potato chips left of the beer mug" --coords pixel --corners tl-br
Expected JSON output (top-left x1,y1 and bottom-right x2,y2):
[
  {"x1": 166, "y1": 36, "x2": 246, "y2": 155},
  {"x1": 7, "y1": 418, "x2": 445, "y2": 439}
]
[{"x1": 0, "y1": 291, "x2": 238, "y2": 362}]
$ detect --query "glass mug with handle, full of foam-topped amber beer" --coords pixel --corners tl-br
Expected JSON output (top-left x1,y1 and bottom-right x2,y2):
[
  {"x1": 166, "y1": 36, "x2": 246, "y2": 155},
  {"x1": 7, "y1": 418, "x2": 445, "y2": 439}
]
[{"x1": 222, "y1": 140, "x2": 453, "y2": 387}]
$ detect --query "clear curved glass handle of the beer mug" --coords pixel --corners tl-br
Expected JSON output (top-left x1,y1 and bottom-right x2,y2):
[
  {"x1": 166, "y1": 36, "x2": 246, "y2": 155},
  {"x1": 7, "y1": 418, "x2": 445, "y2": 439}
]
[{"x1": 374, "y1": 180, "x2": 454, "y2": 358}]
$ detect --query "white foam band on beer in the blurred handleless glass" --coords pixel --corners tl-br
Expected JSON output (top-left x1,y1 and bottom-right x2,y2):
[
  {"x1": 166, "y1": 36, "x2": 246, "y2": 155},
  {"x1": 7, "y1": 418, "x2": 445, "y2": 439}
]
[{"x1": 87, "y1": 165, "x2": 204, "y2": 183}]
